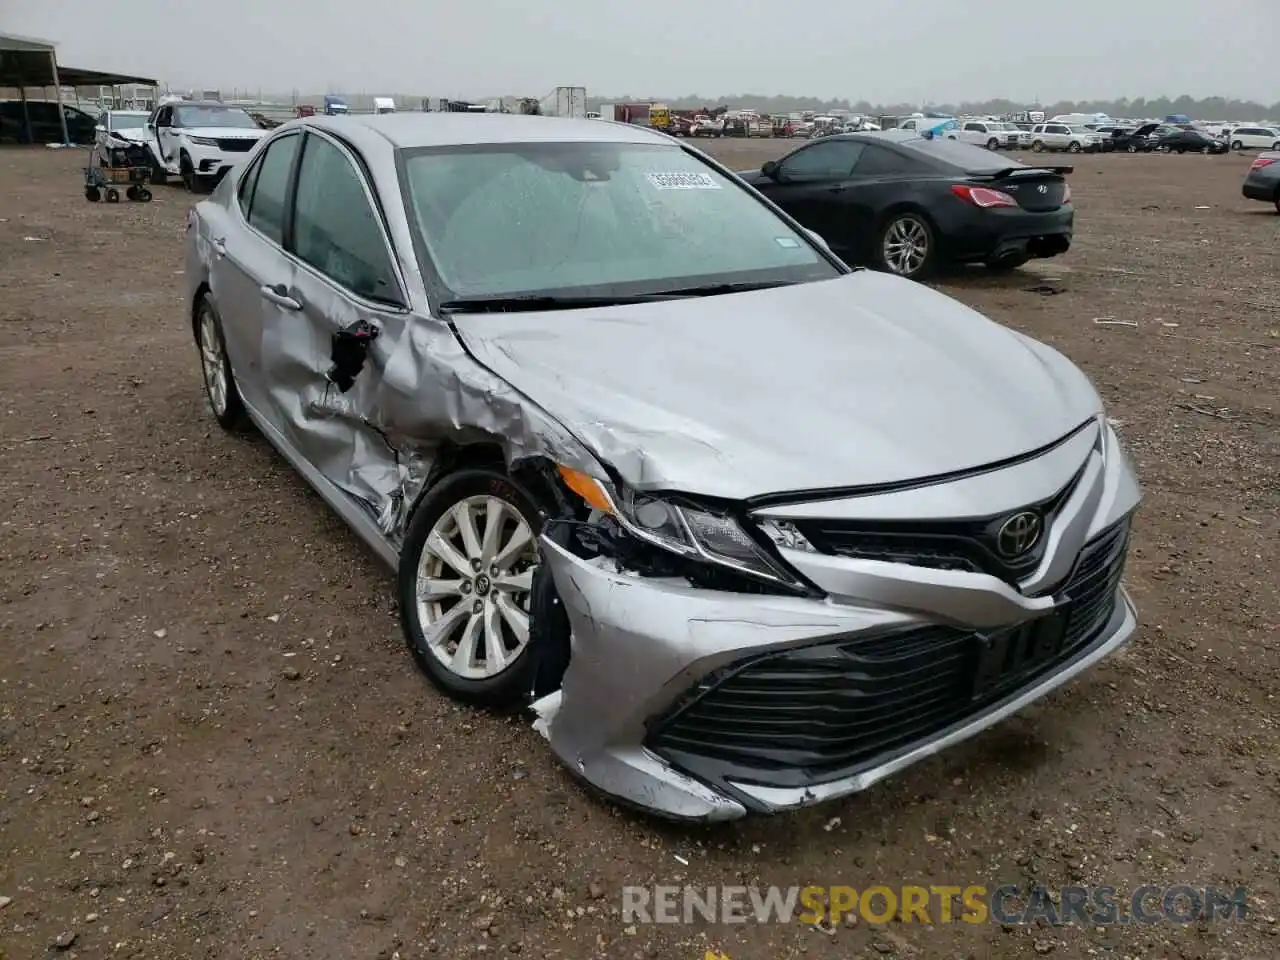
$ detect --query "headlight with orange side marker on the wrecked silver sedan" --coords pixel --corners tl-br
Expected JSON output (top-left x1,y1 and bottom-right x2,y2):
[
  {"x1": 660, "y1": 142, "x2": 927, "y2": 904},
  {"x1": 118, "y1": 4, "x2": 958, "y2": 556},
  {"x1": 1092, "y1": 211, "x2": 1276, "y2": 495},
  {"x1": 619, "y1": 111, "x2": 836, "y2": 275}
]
[{"x1": 559, "y1": 466, "x2": 799, "y2": 586}]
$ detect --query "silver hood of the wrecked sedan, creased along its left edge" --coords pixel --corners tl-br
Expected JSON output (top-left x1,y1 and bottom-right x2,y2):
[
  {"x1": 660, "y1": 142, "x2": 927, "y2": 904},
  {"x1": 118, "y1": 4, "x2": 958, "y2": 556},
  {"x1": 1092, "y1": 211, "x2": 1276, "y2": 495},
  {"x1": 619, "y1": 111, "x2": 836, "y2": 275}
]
[{"x1": 456, "y1": 270, "x2": 1101, "y2": 499}]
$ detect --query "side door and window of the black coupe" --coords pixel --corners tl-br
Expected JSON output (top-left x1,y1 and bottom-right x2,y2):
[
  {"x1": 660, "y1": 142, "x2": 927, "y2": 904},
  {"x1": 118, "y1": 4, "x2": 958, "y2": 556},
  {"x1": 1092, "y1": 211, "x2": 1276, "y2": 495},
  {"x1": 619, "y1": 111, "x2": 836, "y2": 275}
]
[{"x1": 756, "y1": 140, "x2": 863, "y2": 252}]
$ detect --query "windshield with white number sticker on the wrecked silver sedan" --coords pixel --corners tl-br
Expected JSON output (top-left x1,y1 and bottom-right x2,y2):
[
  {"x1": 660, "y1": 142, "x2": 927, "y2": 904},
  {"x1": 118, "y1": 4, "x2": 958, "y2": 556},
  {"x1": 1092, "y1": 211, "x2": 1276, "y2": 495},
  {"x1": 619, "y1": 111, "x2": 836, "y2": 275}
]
[{"x1": 403, "y1": 142, "x2": 842, "y2": 300}]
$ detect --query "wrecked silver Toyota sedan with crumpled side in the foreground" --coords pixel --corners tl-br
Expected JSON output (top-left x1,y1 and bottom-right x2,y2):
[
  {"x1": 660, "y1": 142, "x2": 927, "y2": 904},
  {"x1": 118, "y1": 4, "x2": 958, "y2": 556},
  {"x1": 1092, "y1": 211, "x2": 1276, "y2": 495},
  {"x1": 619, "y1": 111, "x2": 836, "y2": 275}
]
[{"x1": 186, "y1": 114, "x2": 1139, "y2": 819}]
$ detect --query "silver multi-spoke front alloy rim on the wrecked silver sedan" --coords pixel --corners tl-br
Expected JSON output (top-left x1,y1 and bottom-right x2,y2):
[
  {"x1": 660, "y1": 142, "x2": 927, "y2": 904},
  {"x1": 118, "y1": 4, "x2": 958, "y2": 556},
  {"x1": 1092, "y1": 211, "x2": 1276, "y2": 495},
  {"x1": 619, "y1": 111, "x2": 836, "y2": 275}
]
[{"x1": 416, "y1": 497, "x2": 538, "y2": 680}]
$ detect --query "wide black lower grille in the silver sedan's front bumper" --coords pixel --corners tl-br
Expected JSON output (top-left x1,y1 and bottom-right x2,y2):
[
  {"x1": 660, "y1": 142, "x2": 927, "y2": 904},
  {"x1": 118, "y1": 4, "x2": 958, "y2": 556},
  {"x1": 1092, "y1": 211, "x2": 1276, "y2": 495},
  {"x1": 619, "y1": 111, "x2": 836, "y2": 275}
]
[{"x1": 648, "y1": 520, "x2": 1129, "y2": 787}]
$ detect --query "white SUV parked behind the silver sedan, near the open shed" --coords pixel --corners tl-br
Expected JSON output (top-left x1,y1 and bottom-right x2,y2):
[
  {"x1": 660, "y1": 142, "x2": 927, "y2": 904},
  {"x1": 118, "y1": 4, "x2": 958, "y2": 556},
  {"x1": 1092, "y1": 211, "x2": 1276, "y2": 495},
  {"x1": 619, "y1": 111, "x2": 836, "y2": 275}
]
[{"x1": 147, "y1": 100, "x2": 266, "y2": 193}]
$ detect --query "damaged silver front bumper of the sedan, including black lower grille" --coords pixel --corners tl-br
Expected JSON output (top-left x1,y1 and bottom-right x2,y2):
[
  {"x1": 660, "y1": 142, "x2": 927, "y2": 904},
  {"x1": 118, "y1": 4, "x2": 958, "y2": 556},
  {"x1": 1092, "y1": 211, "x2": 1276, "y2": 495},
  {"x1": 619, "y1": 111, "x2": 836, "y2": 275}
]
[{"x1": 534, "y1": 419, "x2": 1140, "y2": 820}]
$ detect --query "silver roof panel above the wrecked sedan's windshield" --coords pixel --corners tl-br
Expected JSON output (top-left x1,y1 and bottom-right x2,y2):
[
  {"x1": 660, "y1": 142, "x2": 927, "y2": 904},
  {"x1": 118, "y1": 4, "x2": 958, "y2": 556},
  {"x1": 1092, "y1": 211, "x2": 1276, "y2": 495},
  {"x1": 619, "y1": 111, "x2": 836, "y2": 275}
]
[{"x1": 300, "y1": 113, "x2": 671, "y2": 148}]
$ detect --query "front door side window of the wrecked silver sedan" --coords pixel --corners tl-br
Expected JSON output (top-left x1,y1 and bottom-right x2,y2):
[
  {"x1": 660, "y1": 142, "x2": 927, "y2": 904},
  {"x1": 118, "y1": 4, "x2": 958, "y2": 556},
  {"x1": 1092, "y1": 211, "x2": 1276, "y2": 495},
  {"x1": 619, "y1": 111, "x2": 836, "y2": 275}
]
[{"x1": 290, "y1": 136, "x2": 401, "y2": 303}]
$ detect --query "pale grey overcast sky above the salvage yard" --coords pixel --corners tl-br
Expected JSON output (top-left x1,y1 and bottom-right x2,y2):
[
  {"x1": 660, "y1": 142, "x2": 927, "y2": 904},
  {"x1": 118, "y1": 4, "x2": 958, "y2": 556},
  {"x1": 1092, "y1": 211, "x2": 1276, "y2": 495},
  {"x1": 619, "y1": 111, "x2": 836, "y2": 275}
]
[{"x1": 0, "y1": 0, "x2": 1280, "y2": 102}]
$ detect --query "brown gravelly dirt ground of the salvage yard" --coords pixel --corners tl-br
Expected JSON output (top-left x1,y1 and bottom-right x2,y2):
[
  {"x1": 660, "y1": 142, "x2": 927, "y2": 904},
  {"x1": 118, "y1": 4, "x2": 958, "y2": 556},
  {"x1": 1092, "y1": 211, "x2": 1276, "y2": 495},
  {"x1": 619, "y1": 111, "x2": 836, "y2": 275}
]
[{"x1": 0, "y1": 142, "x2": 1280, "y2": 960}]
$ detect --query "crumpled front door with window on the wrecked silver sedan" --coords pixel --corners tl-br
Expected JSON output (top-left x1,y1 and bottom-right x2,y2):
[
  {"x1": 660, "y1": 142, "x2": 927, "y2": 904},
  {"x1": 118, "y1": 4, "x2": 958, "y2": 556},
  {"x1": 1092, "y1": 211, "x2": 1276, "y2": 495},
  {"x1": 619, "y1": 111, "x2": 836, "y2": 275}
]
[{"x1": 277, "y1": 129, "x2": 410, "y2": 511}]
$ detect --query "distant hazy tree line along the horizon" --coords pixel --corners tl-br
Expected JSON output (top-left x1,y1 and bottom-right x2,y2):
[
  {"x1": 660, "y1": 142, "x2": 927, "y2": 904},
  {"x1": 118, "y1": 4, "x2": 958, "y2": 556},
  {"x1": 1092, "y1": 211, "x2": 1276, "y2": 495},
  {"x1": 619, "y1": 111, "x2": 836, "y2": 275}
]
[{"x1": 591, "y1": 93, "x2": 1280, "y2": 120}]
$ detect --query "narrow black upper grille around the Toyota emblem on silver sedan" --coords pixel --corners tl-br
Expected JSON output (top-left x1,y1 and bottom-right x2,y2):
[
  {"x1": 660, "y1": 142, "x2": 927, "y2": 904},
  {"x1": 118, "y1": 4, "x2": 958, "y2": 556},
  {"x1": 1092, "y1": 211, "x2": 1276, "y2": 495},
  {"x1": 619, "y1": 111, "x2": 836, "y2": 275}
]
[{"x1": 794, "y1": 471, "x2": 1083, "y2": 585}]
